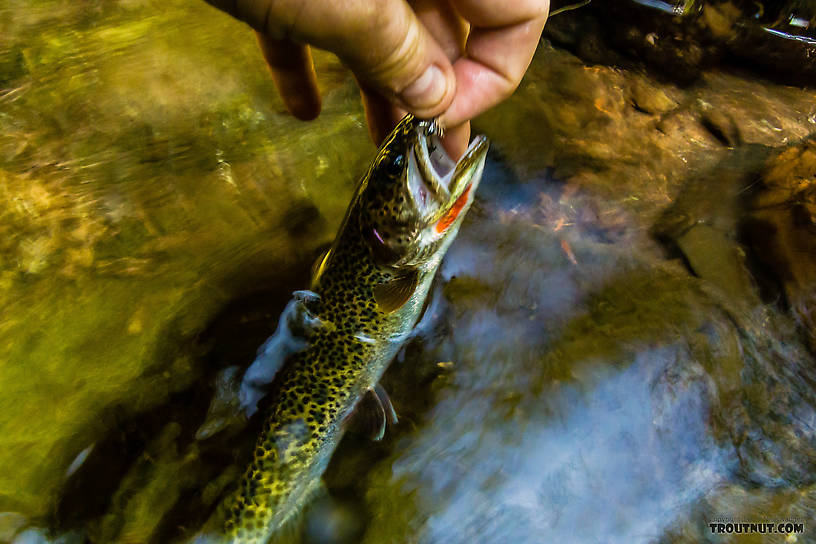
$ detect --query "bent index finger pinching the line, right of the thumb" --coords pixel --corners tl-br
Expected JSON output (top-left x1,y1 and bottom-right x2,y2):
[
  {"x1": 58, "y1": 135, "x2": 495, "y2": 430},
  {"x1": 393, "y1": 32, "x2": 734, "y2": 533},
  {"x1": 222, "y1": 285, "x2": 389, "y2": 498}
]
[{"x1": 442, "y1": 0, "x2": 549, "y2": 126}]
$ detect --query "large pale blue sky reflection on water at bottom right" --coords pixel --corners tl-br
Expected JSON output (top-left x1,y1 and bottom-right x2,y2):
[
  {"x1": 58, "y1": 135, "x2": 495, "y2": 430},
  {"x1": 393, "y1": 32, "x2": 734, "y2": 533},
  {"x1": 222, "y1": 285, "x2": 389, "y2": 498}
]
[{"x1": 412, "y1": 348, "x2": 733, "y2": 542}]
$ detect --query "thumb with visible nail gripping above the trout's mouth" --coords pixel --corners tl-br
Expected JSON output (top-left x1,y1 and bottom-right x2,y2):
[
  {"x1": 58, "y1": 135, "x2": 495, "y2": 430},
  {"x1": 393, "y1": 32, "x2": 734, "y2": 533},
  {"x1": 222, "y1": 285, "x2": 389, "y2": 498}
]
[{"x1": 207, "y1": 0, "x2": 456, "y2": 118}]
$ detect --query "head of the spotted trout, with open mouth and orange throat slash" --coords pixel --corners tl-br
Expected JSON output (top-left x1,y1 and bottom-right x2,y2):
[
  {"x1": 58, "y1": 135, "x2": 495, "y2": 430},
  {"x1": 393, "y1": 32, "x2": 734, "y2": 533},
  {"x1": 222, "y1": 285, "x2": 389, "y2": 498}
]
[{"x1": 359, "y1": 115, "x2": 488, "y2": 270}]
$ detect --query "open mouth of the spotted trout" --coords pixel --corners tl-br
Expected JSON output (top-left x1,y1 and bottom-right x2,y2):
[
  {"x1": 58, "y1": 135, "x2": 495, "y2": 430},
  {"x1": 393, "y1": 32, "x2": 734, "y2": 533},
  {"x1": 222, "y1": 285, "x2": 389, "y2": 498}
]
[{"x1": 408, "y1": 120, "x2": 488, "y2": 224}]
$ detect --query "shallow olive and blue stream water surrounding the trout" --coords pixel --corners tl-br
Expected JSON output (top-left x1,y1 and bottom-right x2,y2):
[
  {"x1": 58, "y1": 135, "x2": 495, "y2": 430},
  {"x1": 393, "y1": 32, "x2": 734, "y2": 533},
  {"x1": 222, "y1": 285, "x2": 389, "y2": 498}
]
[{"x1": 0, "y1": 0, "x2": 816, "y2": 543}]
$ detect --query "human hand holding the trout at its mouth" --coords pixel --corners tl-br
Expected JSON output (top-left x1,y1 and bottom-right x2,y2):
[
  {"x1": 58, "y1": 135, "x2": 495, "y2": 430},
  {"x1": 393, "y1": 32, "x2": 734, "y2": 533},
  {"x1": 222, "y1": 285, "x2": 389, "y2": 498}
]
[{"x1": 206, "y1": 0, "x2": 549, "y2": 157}]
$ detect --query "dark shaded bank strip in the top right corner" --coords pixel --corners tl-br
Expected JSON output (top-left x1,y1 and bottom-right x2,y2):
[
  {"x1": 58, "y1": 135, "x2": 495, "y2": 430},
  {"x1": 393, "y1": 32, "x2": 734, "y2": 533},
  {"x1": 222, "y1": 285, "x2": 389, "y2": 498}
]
[{"x1": 545, "y1": 0, "x2": 816, "y2": 85}]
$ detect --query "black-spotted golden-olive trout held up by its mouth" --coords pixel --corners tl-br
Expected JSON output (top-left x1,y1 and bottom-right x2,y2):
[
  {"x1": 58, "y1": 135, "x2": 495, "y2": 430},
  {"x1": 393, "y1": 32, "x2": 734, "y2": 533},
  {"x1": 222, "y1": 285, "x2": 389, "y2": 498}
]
[{"x1": 215, "y1": 115, "x2": 489, "y2": 544}]
